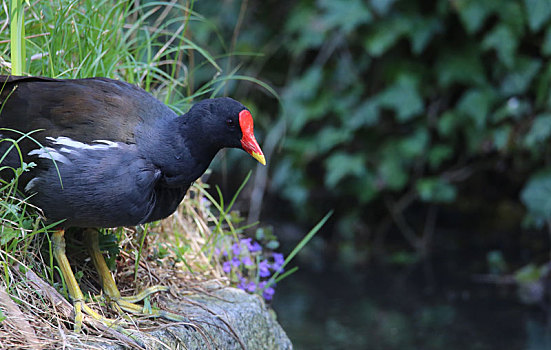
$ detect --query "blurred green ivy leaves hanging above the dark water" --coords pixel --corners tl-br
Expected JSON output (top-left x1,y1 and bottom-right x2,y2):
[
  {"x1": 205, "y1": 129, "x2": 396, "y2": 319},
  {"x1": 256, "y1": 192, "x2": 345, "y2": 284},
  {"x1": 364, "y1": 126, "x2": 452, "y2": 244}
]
[{"x1": 193, "y1": 0, "x2": 551, "y2": 262}]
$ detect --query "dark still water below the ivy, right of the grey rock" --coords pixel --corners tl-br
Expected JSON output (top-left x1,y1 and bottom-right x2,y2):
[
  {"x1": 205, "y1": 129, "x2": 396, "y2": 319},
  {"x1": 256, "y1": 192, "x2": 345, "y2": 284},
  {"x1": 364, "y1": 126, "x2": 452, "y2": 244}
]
[{"x1": 273, "y1": 268, "x2": 551, "y2": 350}]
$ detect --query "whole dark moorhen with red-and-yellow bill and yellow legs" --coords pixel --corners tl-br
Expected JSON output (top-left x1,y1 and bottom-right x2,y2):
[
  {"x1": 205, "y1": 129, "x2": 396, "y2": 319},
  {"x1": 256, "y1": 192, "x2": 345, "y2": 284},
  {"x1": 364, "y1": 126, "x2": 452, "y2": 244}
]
[{"x1": 0, "y1": 76, "x2": 265, "y2": 331}]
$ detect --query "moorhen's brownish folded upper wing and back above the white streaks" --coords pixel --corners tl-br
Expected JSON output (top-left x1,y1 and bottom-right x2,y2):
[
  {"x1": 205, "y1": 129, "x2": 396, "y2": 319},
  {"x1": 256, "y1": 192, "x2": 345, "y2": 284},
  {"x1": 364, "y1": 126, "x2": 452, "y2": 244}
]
[{"x1": 0, "y1": 76, "x2": 176, "y2": 147}]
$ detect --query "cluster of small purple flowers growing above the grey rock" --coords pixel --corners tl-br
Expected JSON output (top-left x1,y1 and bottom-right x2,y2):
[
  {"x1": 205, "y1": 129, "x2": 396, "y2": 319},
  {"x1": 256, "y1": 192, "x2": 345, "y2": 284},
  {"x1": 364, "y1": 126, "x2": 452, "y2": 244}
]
[{"x1": 215, "y1": 238, "x2": 285, "y2": 301}]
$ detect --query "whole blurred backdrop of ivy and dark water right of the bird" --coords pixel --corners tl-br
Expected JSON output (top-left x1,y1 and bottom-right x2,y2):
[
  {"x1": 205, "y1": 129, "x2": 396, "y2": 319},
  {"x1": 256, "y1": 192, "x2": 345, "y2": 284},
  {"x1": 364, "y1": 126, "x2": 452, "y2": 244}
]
[{"x1": 191, "y1": 0, "x2": 551, "y2": 349}]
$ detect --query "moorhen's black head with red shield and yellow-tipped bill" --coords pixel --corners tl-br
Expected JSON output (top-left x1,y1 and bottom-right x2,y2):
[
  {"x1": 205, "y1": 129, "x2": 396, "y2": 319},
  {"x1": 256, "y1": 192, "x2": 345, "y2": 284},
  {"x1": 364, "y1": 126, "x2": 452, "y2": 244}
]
[{"x1": 190, "y1": 97, "x2": 266, "y2": 165}]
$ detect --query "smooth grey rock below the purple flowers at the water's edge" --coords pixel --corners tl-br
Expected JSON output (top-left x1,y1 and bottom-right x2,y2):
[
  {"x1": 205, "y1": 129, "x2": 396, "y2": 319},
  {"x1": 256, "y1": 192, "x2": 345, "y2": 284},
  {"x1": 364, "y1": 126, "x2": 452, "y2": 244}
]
[{"x1": 95, "y1": 288, "x2": 293, "y2": 350}]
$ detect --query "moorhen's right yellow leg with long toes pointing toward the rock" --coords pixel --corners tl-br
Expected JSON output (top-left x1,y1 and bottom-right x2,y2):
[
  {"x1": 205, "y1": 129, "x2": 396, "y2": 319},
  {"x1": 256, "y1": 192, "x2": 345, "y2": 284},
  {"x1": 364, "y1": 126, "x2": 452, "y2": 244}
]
[{"x1": 84, "y1": 229, "x2": 184, "y2": 322}]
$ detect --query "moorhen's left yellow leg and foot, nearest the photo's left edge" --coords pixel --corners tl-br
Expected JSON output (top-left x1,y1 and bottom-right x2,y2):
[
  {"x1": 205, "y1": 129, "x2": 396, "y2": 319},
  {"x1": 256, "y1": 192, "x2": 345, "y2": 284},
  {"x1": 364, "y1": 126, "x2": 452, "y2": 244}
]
[{"x1": 52, "y1": 230, "x2": 113, "y2": 332}]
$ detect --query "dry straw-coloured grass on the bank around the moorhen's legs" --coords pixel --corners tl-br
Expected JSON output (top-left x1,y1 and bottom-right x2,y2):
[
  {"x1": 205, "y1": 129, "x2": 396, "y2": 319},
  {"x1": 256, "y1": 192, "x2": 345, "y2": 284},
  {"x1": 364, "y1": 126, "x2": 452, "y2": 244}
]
[{"x1": 0, "y1": 185, "x2": 233, "y2": 349}]
